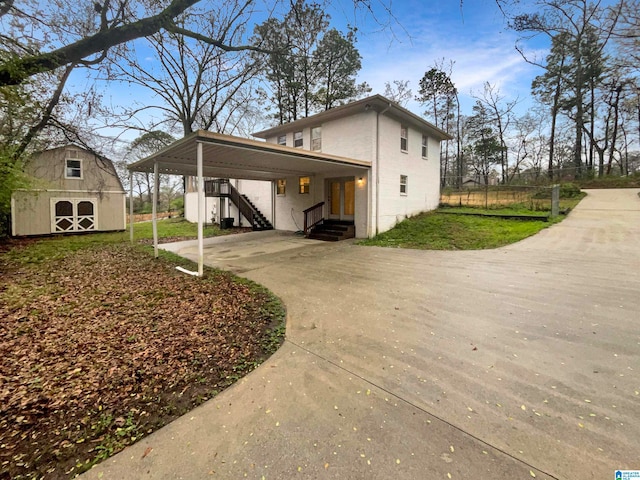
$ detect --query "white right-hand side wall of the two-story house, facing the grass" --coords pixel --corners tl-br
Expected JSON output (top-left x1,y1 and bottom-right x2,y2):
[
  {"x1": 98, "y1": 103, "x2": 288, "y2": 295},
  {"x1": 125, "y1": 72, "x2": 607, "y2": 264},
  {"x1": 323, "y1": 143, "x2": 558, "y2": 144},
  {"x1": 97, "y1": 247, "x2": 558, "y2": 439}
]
[{"x1": 374, "y1": 115, "x2": 440, "y2": 233}]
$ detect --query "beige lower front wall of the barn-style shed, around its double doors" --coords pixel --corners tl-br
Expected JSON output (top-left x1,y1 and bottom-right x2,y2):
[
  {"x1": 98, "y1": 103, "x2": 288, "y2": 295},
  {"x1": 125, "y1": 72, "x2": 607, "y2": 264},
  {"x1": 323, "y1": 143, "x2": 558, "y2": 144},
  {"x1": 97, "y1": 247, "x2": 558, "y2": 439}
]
[{"x1": 11, "y1": 191, "x2": 126, "y2": 236}]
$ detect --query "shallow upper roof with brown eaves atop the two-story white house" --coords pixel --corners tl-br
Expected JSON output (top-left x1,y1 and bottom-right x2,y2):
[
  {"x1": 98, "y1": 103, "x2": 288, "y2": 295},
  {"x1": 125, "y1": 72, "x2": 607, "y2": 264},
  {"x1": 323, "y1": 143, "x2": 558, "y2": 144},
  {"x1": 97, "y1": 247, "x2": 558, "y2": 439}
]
[{"x1": 252, "y1": 95, "x2": 453, "y2": 141}]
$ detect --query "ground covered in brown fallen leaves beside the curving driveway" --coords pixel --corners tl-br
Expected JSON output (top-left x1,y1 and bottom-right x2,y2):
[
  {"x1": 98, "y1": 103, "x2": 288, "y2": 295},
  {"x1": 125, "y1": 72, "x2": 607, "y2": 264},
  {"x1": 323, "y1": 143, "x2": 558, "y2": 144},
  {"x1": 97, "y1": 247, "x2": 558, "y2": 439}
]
[{"x1": 0, "y1": 243, "x2": 284, "y2": 479}]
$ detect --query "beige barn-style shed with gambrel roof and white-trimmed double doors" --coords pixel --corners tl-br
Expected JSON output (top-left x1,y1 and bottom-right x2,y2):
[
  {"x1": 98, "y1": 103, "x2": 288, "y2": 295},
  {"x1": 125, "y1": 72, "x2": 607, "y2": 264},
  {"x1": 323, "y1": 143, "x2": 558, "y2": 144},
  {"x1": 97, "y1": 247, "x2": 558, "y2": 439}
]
[{"x1": 11, "y1": 145, "x2": 126, "y2": 236}]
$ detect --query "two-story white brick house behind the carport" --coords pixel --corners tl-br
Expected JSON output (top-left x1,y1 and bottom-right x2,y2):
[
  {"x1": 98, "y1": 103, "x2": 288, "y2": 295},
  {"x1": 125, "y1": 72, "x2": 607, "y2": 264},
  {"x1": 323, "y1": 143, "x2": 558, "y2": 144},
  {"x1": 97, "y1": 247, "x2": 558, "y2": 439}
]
[{"x1": 172, "y1": 95, "x2": 450, "y2": 242}]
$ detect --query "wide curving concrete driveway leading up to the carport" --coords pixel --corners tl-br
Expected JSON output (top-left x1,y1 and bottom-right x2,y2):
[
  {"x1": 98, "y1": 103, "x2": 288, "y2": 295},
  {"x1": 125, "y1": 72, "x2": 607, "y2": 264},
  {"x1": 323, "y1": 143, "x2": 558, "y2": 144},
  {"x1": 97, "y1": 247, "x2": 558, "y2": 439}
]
[{"x1": 84, "y1": 190, "x2": 640, "y2": 480}]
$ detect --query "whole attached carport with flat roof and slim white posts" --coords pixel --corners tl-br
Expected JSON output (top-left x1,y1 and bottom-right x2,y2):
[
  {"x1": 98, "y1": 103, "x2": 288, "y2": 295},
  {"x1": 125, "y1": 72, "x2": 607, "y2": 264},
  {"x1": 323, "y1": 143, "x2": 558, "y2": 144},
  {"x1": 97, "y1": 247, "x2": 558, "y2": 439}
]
[{"x1": 129, "y1": 130, "x2": 371, "y2": 276}]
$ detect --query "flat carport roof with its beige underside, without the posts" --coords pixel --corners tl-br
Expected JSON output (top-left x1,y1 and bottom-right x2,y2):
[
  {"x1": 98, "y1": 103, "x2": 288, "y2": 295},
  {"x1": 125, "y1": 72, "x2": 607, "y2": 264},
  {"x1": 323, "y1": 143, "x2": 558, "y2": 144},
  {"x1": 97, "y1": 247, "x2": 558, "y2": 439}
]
[{"x1": 129, "y1": 130, "x2": 371, "y2": 180}]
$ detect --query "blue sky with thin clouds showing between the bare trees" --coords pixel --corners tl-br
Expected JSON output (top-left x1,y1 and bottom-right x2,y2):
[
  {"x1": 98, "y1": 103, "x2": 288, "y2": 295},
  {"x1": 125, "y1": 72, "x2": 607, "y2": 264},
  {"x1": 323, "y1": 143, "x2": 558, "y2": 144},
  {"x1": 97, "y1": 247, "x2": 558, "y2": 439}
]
[{"x1": 75, "y1": 0, "x2": 544, "y2": 140}]
